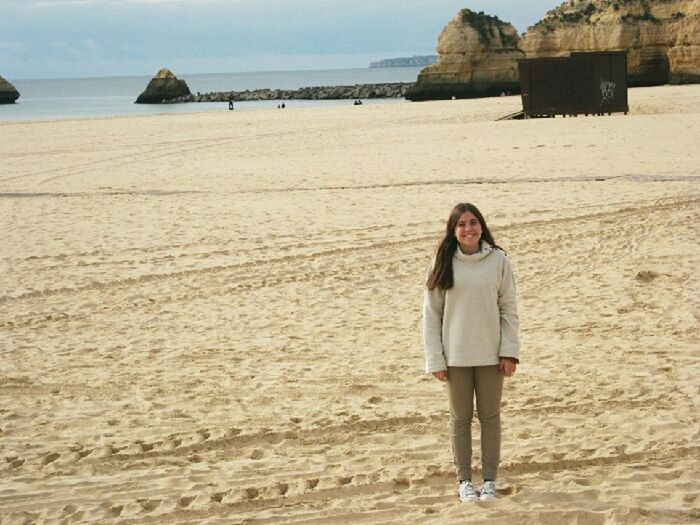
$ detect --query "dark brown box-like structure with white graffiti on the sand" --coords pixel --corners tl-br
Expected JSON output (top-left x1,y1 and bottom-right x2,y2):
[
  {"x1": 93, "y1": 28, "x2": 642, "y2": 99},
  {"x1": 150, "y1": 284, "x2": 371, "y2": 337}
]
[{"x1": 518, "y1": 51, "x2": 629, "y2": 117}]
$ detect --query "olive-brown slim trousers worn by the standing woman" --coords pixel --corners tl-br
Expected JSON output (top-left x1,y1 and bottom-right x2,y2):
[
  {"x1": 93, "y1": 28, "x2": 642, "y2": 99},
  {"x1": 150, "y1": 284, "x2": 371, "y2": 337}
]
[{"x1": 447, "y1": 365, "x2": 503, "y2": 481}]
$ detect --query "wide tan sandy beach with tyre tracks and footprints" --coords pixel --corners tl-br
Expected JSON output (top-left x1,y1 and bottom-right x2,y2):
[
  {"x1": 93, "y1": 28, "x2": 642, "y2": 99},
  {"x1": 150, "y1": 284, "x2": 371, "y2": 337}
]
[{"x1": 0, "y1": 85, "x2": 700, "y2": 525}]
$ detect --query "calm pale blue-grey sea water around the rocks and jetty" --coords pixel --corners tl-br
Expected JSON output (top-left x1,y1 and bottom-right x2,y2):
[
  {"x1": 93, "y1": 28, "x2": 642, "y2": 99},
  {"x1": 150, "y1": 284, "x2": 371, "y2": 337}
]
[{"x1": 0, "y1": 67, "x2": 422, "y2": 121}]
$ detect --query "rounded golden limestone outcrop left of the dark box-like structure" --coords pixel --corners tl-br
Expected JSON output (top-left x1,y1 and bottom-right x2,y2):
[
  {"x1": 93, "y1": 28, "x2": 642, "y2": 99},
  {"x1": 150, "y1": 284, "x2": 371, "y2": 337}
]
[{"x1": 406, "y1": 9, "x2": 524, "y2": 100}]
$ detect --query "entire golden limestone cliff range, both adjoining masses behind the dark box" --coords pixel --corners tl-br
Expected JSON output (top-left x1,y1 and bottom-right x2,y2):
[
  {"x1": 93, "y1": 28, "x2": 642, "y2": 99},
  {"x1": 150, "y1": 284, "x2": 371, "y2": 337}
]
[{"x1": 406, "y1": 0, "x2": 700, "y2": 100}]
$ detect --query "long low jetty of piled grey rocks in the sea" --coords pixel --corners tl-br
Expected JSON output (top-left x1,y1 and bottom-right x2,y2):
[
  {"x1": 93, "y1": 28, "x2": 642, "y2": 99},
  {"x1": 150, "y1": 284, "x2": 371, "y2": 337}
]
[{"x1": 168, "y1": 82, "x2": 413, "y2": 103}]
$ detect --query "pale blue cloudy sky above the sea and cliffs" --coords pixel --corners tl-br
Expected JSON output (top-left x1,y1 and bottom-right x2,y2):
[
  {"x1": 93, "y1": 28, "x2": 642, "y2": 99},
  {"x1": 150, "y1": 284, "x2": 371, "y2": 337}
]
[{"x1": 0, "y1": 0, "x2": 561, "y2": 80}]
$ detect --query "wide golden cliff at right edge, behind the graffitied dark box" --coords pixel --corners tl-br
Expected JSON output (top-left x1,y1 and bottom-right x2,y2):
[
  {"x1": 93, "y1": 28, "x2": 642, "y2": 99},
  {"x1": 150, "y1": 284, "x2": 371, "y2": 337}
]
[{"x1": 519, "y1": 0, "x2": 700, "y2": 86}]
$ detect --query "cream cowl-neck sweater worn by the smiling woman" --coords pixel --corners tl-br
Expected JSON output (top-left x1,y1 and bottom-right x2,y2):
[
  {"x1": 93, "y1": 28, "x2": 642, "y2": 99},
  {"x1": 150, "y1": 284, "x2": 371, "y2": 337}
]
[{"x1": 423, "y1": 241, "x2": 520, "y2": 373}]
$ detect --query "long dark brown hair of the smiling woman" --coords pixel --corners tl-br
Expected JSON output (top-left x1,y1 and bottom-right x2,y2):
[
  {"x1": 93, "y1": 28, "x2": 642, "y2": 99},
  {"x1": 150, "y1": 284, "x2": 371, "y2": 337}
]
[{"x1": 426, "y1": 202, "x2": 501, "y2": 290}]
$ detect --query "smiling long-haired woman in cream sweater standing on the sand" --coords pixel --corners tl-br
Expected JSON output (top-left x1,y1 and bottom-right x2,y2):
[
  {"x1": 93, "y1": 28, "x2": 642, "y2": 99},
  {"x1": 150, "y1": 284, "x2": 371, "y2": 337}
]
[{"x1": 423, "y1": 203, "x2": 520, "y2": 502}]
